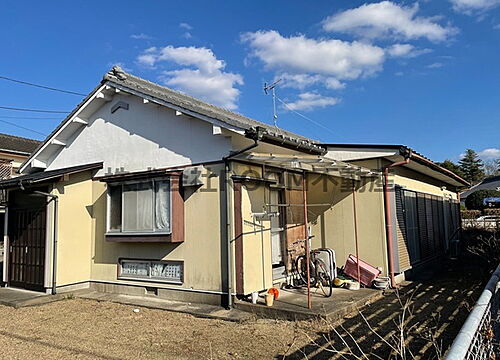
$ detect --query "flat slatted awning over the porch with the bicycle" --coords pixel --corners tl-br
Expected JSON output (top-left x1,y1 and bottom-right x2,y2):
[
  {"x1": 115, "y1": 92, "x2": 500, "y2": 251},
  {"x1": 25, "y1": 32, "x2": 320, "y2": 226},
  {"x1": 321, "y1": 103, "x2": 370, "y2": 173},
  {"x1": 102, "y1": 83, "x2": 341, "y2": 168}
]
[{"x1": 234, "y1": 152, "x2": 382, "y2": 180}]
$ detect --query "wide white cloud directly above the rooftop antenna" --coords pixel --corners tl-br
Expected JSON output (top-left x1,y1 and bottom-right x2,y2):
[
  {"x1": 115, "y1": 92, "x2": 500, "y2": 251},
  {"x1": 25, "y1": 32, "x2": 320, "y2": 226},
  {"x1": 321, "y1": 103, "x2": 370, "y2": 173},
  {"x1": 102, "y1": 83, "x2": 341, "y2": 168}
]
[{"x1": 241, "y1": 31, "x2": 385, "y2": 80}]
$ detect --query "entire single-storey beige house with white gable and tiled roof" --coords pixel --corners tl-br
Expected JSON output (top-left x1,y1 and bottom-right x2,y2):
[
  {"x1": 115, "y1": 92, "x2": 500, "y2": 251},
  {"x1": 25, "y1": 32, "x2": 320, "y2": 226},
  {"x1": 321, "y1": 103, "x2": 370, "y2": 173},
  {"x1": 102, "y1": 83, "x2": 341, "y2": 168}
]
[{"x1": 0, "y1": 67, "x2": 466, "y2": 305}]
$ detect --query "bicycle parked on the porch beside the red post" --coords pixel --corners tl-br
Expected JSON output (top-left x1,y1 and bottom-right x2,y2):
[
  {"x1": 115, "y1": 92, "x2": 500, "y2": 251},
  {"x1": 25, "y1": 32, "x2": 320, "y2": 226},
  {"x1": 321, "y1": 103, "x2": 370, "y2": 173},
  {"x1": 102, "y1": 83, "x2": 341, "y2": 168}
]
[{"x1": 295, "y1": 236, "x2": 333, "y2": 297}]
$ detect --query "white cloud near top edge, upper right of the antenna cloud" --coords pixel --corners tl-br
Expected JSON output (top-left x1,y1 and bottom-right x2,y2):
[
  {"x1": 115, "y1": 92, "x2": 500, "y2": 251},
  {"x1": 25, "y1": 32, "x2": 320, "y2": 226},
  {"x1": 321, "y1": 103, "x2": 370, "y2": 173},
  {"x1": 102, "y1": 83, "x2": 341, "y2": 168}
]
[{"x1": 322, "y1": 0, "x2": 458, "y2": 42}]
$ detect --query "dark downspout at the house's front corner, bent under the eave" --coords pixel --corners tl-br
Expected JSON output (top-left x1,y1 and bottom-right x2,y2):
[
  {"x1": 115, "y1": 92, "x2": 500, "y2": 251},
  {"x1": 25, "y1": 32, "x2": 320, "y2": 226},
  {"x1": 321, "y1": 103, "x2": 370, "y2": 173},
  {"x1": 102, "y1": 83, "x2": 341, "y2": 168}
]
[{"x1": 222, "y1": 134, "x2": 260, "y2": 309}]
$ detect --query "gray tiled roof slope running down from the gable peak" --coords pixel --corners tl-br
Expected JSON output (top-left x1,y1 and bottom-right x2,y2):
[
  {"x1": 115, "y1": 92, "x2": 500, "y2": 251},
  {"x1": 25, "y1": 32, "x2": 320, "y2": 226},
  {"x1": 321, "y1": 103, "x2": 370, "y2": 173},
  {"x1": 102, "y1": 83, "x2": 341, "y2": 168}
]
[{"x1": 104, "y1": 66, "x2": 316, "y2": 144}]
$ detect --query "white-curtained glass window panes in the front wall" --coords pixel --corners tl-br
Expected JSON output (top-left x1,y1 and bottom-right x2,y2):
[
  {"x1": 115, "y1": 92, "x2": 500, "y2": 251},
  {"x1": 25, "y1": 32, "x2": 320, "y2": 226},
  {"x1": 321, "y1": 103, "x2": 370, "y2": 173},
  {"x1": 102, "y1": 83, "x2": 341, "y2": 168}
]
[{"x1": 108, "y1": 179, "x2": 171, "y2": 234}]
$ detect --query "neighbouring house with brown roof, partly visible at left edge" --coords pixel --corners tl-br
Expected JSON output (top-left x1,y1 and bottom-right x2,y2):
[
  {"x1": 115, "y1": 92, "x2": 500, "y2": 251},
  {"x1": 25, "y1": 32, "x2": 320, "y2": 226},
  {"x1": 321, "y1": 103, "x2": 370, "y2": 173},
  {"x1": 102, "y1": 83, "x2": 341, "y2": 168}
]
[{"x1": 0, "y1": 134, "x2": 40, "y2": 276}]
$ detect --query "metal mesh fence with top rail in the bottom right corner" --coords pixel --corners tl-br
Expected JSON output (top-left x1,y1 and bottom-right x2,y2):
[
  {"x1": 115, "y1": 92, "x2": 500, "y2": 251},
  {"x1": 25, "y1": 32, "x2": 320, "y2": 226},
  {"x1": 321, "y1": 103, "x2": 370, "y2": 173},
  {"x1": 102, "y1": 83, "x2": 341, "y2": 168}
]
[{"x1": 445, "y1": 265, "x2": 500, "y2": 360}]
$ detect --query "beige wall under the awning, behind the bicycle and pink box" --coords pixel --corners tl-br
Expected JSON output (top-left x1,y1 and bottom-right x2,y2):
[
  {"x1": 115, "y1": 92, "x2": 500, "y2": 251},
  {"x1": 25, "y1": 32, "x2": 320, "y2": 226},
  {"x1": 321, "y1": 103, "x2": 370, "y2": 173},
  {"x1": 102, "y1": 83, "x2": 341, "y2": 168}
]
[{"x1": 307, "y1": 175, "x2": 387, "y2": 273}]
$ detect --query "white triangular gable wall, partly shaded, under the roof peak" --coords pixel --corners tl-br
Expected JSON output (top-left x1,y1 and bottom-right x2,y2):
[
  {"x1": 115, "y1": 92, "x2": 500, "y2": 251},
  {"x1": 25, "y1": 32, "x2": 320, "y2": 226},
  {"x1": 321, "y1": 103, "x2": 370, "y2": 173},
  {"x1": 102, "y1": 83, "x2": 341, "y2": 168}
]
[{"x1": 46, "y1": 94, "x2": 231, "y2": 175}]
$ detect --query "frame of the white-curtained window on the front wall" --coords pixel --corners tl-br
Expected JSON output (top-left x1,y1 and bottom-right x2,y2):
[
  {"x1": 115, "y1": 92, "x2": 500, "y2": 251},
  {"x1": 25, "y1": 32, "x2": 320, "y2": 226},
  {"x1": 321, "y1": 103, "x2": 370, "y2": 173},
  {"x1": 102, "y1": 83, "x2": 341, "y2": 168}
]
[{"x1": 105, "y1": 176, "x2": 173, "y2": 237}]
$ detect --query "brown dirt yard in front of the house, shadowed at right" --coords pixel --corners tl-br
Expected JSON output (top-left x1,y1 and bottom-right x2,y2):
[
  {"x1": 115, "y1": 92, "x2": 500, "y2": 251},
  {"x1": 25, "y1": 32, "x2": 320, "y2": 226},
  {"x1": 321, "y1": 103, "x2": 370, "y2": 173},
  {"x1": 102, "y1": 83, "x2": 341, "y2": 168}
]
[{"x1": 0, "y1": 260, "x2": 488, "y2": 360}]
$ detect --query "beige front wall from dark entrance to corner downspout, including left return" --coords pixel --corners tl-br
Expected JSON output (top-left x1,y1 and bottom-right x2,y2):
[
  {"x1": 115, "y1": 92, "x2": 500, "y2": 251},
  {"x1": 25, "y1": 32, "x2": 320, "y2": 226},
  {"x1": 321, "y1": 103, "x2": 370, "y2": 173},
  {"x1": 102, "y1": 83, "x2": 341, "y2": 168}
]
[{"x1": 53, "y1": 165, "x2": 222, "y2": 293}]
